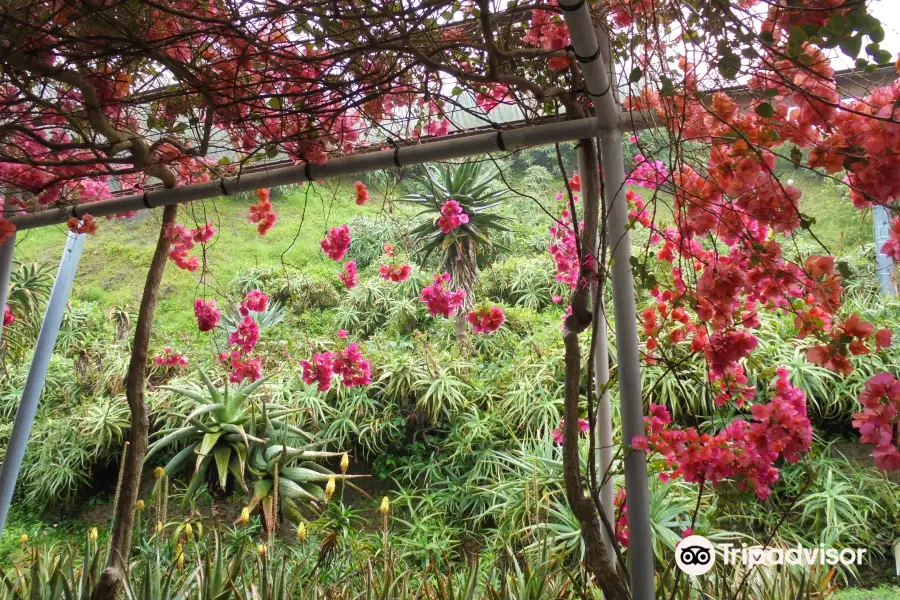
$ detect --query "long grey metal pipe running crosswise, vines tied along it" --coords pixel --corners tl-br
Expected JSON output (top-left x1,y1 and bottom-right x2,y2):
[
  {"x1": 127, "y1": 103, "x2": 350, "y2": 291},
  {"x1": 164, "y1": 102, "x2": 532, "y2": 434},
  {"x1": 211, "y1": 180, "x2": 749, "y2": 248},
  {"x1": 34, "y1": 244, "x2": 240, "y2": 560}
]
[{"x1": 9, "y1": 118, "x2": 600, "y2": 230}]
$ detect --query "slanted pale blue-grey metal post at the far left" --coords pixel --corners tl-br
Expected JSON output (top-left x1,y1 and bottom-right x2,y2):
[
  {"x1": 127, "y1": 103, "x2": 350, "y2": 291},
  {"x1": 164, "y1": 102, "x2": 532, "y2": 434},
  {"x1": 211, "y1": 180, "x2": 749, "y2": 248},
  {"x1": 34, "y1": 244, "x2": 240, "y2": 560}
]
[{"x1": 0, "y1": 233, "x2": 86, "y2": 536}]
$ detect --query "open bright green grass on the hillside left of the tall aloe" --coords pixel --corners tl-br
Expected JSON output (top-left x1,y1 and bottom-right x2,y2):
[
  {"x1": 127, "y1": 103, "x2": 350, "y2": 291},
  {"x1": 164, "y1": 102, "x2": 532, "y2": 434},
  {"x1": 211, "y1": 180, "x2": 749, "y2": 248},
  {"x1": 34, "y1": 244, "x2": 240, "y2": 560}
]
[{"x1": 16, "y1": 180, "x2": 381, "y2": 341}]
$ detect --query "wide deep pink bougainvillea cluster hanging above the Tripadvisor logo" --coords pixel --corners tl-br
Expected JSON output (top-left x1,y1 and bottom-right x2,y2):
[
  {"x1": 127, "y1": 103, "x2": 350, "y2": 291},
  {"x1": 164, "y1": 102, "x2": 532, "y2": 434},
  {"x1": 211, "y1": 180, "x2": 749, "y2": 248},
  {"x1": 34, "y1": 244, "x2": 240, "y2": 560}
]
[{"x1": 631, "y1": 367, "x2": 812, "y2": 500}]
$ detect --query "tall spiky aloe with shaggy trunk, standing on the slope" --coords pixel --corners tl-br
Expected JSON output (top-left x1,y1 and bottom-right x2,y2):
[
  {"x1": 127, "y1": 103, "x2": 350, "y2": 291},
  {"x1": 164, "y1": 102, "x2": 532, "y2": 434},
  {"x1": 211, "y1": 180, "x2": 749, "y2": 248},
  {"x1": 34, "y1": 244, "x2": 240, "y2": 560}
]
[{"x1": 400, "y1": 160, "x2": 509, "y2": 340}]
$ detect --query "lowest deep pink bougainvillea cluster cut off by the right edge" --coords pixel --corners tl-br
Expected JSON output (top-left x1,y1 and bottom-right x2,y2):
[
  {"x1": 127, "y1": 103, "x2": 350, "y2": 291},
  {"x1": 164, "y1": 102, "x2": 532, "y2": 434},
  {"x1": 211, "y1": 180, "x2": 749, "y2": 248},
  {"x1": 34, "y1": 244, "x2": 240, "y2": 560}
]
[{"x1": 853, "y1": 373, "x2": 900, "y2": 471}]
